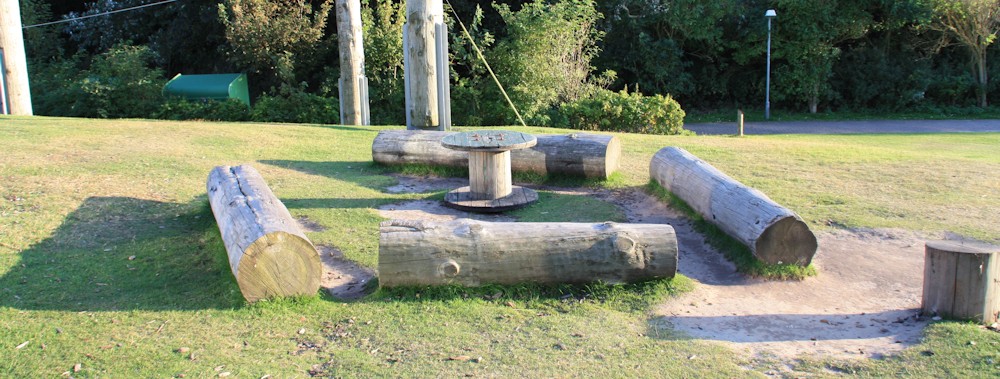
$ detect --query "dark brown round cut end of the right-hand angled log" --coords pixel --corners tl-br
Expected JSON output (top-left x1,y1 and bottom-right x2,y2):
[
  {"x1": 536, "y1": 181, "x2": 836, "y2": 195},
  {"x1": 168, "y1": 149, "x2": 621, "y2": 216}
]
[{"x1": 754, "y1": 217, "x2": 819, "y2": 267}]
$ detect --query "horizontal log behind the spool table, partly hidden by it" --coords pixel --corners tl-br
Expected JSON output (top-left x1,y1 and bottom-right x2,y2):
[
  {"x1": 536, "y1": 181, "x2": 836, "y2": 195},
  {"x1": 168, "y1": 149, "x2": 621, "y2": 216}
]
[{"x1": 372, "y1": 130, "x2": 621, "y2": 179}]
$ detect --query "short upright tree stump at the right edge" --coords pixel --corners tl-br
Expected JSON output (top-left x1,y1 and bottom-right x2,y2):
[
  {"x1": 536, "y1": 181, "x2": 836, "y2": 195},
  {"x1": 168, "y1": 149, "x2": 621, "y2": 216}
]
[{"x1": 920, "y1": 241, "x2": 1000, "y2": 325}]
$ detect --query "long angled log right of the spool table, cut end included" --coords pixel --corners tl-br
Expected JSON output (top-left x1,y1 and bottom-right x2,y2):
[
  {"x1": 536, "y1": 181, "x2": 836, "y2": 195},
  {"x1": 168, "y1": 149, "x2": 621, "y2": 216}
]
[{"x1": 649, "y1": 147, "x2": 817, "y2": 266}]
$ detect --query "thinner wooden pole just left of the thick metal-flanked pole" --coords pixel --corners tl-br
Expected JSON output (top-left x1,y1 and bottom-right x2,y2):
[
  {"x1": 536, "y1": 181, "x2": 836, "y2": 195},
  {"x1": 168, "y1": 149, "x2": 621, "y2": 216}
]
[{"x1": 336, "y1": 0, "x2": 370, "y2": 125}]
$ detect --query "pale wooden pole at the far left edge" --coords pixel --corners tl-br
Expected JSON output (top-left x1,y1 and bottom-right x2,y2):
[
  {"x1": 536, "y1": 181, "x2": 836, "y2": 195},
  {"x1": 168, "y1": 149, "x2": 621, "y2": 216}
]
[{"x1": 0, "y1": 0, "x2": 32, "y2": 116}]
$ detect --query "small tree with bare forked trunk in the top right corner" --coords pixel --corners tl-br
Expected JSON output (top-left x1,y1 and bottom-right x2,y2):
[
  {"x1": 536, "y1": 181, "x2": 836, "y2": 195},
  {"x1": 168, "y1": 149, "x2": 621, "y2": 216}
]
[{"x1": 929, "y1": 0, "x2": 1000, "y2": 108}]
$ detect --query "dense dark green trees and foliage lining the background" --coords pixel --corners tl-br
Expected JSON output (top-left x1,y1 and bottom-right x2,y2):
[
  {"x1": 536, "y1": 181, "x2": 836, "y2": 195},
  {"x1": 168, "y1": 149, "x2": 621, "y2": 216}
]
[{"x1": 13, "y1": 0, "x2": 1000, "y2": 125}]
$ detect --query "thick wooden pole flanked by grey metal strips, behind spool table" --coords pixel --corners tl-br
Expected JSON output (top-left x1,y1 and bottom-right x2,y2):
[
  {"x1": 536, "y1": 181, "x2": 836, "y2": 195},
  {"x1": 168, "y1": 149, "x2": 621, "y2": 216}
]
[{"x1": 403, "y1": 0, "x2": 451, "y2": 130}]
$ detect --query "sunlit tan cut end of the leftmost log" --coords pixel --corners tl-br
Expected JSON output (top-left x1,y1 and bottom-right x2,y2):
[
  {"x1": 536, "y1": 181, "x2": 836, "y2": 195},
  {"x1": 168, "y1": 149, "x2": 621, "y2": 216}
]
[{"x1": 236, "y1": 232, "x2": 323, "y2": 302}]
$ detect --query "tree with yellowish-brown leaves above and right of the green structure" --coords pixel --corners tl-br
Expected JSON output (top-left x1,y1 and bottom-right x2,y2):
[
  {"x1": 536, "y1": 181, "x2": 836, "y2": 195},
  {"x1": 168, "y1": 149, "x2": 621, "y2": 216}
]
[{"x1": 219, "y1": 0, "x2": 333, "y2": 90}]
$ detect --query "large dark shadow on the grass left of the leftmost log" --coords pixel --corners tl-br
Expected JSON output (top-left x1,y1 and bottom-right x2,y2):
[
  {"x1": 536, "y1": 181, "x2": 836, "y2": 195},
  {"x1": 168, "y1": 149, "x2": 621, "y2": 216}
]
[{"x1": 0, "y1": 197, "x2": 243, "y2": 311}]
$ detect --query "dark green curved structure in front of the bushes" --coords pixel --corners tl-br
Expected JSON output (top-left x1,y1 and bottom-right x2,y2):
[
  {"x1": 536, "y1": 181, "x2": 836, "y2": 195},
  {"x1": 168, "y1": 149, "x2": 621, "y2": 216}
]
[{"x1": 163, "y1": 74, "x2": 250, "y2": 106}]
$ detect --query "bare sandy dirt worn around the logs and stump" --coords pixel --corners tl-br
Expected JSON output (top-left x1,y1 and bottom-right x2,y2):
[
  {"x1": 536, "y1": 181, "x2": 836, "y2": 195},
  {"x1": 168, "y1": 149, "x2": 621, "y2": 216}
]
[{"x1": 324, "y1": 176, "x2": 929, "y2": 361}]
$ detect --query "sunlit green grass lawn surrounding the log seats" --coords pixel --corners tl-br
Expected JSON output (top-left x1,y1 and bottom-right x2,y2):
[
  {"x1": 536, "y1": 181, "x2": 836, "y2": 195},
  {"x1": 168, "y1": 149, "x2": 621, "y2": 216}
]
[{"x1": 0, "y1": 116, "x2": 1000, "y2": 378}]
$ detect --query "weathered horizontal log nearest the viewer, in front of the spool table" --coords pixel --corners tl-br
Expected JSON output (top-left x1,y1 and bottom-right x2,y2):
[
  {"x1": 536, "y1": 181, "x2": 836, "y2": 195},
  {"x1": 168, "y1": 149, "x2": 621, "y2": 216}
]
[{"x1": 378, "y1": 219, "x2": 677, "y2": 287}]
